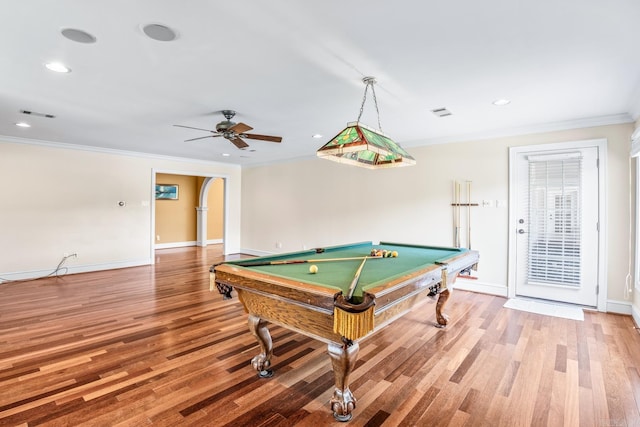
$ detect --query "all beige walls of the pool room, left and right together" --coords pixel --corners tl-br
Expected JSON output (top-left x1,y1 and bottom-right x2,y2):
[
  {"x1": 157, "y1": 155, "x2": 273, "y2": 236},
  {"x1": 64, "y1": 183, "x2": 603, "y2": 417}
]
[{"x1": 0, "y1": 124, "x2": 640, "y2": 307}]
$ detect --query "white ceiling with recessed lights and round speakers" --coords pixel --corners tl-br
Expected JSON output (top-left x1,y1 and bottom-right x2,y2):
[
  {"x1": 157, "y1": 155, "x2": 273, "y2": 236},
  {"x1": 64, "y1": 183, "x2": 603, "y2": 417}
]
[{"x1": 0, "y1": 0, "x2": 640, "y2": 165}]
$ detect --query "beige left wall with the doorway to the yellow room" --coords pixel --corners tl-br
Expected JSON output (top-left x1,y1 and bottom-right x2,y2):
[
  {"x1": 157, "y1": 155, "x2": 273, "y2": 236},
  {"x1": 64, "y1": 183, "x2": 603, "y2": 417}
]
[{"x1": 0, "y1": 137, "x2": 241, "y2": 279}]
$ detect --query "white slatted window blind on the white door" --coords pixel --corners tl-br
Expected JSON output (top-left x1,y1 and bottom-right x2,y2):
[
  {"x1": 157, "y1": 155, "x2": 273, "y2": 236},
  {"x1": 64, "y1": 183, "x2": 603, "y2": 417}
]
[{"x1": 527, "y1": 153, "x2": 582, "y2": 287}]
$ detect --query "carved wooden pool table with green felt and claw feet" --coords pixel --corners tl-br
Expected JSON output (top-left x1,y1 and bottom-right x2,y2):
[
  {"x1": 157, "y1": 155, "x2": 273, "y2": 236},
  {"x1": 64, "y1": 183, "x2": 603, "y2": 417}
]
[{"x1": 210, "y1": 242, "x2": 479, "y2": 421}]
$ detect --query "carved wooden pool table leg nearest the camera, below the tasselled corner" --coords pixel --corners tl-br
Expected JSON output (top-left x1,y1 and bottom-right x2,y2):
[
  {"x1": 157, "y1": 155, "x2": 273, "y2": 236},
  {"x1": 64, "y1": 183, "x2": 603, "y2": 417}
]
[{"x1": 329, "y1": 340, "x2": 360, "y2": 422}]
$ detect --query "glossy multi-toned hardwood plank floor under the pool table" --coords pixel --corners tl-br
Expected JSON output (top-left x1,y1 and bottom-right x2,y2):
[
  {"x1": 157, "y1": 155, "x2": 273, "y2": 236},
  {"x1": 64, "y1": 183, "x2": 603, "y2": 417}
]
[{"x1": 0, "y1": 246, "x2": 640, "y2": 427}]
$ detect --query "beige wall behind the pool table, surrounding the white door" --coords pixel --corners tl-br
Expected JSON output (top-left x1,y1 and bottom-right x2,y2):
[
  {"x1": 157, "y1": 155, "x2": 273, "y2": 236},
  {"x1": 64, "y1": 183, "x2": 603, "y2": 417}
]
[{"x1": 242, "y1": 124, "x2": 633, "y2": 307}]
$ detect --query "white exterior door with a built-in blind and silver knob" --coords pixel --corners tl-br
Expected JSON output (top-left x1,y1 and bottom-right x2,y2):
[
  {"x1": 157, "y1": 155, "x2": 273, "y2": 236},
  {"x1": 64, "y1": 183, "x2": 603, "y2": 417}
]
[{"x1": 511, "y1": 147, "x2": 599, "y2": 307}]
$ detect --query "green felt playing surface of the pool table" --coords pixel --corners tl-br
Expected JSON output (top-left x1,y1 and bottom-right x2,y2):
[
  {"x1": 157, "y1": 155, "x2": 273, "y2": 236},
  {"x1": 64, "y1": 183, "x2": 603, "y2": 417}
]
[{"x1": 220, "y1": 242, "x2": 468, "y2": 296}]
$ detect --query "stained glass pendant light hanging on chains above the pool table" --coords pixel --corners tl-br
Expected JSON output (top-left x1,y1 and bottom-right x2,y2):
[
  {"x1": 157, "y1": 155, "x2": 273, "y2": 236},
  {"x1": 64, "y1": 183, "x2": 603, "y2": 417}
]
[{"x1": 316, "y1": 77, "x2": 416, "y2": 169}]
